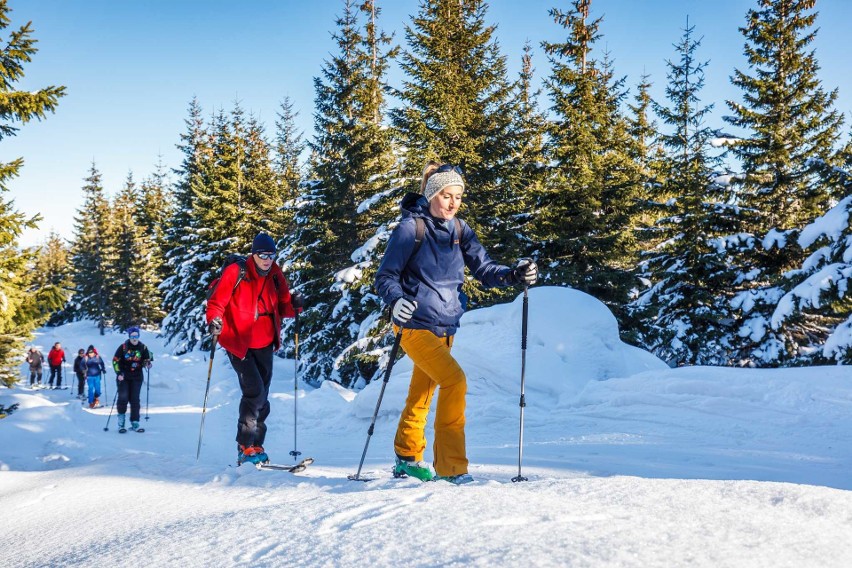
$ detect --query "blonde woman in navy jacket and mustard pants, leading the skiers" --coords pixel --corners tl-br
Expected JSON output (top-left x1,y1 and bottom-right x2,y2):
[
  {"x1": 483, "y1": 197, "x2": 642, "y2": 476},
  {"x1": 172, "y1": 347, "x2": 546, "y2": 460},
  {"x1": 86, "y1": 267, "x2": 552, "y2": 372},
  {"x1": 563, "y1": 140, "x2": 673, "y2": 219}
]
[{"x1": 376, "y1": 162, "x2": 538, "y2": 484}]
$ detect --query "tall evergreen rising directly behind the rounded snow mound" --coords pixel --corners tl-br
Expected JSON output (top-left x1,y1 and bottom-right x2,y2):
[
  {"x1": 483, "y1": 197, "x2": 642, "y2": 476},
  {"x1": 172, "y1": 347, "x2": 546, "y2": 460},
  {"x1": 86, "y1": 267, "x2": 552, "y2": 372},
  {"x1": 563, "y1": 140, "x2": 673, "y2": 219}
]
[{"x1": 534, "y1": 0, "x2": 642, "y2": 316}]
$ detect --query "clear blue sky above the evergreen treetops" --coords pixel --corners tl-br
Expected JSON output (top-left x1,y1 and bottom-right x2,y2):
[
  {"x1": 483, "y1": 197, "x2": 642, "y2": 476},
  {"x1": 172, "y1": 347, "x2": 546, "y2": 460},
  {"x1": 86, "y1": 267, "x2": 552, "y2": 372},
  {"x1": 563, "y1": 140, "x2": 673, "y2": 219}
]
[{"x1": 8, "y1": 0, "x2": 852, "y2": 245}]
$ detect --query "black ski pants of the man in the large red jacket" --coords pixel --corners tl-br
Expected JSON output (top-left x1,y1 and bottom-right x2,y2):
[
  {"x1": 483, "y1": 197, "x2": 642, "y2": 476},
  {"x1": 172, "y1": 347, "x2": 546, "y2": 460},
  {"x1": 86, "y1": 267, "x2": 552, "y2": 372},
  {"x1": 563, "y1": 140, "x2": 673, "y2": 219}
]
[{"x1": 228, "y1": 344, "x2": 272, "y2": 447}]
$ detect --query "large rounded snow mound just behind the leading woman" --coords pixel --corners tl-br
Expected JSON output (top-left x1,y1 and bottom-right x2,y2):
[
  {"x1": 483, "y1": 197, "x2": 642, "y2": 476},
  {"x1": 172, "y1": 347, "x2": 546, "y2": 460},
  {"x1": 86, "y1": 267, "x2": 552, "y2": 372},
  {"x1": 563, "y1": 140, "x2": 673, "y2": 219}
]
[{"x1": 353, "y1": 287, "x2": 668, "y2": 418}]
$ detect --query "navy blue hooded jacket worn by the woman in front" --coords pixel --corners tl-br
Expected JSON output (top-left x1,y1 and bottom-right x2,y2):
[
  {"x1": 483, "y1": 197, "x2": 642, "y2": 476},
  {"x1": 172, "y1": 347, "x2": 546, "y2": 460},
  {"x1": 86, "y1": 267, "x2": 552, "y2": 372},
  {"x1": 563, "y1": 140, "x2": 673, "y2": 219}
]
[{"x1": 376, "y1": 193, "x2": 516, "y2": 337}]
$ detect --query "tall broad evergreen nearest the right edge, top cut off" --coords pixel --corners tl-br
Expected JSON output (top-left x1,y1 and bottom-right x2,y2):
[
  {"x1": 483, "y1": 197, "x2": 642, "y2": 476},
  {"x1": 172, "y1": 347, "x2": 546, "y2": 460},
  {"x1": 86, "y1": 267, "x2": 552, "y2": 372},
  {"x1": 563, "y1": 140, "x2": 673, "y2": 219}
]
[{"x1": 727, "y1": 0, "x2": 842, "y2": 366}]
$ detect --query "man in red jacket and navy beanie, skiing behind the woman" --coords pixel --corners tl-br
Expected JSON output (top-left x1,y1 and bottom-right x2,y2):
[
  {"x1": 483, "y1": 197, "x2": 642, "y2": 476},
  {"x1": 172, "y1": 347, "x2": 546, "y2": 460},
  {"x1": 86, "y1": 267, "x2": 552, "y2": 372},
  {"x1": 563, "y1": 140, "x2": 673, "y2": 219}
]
[{"x1": 207, "y1": 233, "x2": 303, "y2": 465}]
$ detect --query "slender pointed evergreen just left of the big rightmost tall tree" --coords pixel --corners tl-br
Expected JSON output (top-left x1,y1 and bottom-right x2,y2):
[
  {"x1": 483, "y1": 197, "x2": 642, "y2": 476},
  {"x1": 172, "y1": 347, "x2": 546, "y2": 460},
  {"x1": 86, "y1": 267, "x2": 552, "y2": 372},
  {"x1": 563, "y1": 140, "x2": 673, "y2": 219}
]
[{"x1": 630, "y1": 24, "x2": 735, "y2": 365}]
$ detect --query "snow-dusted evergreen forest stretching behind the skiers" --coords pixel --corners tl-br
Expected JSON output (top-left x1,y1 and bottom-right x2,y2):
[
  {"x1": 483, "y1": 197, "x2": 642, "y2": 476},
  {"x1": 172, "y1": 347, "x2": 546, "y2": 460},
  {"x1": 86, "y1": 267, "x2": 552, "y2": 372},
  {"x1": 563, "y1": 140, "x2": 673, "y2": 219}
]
[{"x1": 6, "y1": 0, "x2": 852, "y2": 387}]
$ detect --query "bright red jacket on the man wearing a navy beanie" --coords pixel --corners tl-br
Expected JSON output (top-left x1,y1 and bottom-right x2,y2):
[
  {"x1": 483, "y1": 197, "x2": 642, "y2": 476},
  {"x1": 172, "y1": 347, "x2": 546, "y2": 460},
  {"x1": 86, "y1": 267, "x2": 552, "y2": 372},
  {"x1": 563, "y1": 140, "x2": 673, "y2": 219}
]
[{"x1": 207, "y1": 257, "x2": 296, "y2": 359}]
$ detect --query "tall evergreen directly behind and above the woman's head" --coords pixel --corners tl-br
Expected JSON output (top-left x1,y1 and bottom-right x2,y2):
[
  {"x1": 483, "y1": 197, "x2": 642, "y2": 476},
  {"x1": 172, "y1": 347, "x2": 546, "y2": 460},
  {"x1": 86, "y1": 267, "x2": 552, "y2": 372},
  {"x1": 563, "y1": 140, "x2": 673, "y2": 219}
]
[{"x1": 391, "y1": 0, "x2": 525, "y2": 306}]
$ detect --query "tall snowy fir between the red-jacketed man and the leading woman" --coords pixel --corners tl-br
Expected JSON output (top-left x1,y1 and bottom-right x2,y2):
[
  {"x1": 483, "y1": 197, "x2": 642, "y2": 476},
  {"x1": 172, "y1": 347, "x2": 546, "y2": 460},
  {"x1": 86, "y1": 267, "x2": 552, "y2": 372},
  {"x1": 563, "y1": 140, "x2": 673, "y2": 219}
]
[{"x1": 290, "y1": 0, "x2": 402, "y2": 386}]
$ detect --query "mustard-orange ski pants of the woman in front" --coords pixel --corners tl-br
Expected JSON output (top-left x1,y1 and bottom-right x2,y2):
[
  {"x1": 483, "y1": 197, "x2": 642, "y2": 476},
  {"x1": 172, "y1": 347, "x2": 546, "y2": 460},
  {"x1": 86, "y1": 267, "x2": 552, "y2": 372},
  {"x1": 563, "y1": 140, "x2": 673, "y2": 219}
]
[{"x1": 394, "y1": 327, "x2": 467, "y2": 477}]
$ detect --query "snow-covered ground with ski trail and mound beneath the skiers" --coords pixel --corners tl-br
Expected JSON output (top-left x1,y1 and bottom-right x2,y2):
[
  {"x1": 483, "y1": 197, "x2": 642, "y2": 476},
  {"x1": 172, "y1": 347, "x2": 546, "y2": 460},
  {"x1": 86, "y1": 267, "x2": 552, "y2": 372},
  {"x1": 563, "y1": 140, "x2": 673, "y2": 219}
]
[{"x1": 0, "y1": 288, "x2": 852, "y2": 568}]
